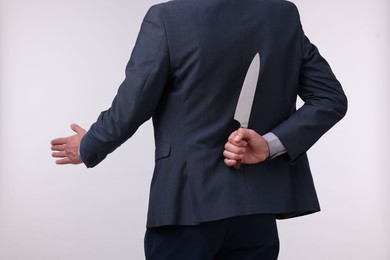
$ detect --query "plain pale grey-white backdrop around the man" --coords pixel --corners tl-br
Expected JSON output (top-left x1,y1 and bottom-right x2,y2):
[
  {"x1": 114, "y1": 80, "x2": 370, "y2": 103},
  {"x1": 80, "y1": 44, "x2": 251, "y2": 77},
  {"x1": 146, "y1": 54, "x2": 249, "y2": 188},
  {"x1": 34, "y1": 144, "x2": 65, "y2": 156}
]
[{"x1": 0, "y1": 0, "x2": 390, "y2": 260}]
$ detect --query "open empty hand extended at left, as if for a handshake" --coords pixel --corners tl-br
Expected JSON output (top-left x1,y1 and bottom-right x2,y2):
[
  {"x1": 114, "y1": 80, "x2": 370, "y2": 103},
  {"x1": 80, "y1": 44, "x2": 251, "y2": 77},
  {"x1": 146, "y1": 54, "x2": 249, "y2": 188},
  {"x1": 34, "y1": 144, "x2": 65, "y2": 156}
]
[{"x1": 51, "y1": 124, "x2": 87, "y2": 164}]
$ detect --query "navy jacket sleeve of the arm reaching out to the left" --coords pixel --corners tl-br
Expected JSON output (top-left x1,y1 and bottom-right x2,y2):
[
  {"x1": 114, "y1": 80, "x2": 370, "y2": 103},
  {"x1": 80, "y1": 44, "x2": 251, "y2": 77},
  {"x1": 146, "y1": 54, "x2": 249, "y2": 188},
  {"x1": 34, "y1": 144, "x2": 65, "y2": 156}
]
[{"x1": 80, "y1": 7, "x2": 169, "y2": 167}]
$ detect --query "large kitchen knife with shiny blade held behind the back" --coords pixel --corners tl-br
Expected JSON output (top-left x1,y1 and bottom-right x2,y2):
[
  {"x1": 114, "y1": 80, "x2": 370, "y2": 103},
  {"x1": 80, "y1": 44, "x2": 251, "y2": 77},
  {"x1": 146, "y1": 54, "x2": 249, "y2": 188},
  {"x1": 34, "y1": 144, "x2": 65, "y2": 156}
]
[{"x1": 234, "y1": 53, "x2": 260, "y2": 169}]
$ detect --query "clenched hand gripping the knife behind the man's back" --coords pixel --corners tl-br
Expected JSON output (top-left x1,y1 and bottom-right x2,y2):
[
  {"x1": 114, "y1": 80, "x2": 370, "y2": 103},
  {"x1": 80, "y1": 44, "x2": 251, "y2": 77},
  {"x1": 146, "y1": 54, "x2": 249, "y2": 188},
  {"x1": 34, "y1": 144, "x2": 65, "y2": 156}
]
[{"x1": 223, "y1": 128, "x2": 269, "y2": 168}]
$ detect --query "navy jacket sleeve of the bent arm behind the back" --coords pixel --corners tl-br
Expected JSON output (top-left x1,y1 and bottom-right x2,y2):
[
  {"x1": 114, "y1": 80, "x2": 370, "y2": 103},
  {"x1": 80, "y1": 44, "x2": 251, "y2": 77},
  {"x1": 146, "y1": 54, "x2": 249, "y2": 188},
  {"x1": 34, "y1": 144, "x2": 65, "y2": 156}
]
[{"x1": 272, "y1": 32, "x2": 347, "y2": 161}]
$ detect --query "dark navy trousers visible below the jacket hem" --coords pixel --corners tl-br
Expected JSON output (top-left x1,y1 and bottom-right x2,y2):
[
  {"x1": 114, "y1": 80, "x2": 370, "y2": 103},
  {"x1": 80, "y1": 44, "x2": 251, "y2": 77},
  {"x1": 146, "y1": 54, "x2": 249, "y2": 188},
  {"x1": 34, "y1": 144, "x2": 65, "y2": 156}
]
[{"x1": 145, "y1": 215, "x2": 279, "y2": 260}]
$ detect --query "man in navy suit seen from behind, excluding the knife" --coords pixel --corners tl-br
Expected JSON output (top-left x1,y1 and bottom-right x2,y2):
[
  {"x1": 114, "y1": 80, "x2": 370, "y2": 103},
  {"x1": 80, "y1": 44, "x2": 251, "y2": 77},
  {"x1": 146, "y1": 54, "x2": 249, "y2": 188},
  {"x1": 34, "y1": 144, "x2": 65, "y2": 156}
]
[{"x1": 52, "y1": 0, "x2": 347, "y2": 260}]
